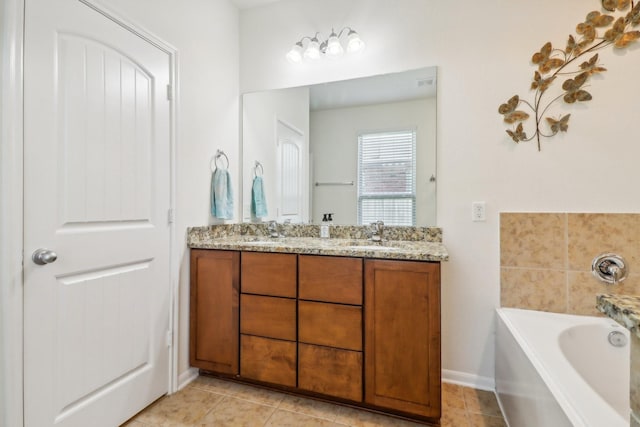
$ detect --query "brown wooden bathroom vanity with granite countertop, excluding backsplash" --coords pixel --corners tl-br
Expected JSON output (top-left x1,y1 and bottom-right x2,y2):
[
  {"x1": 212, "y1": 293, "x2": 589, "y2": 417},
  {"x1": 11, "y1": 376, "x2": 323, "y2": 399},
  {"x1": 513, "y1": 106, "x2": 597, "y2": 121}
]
[{"x1": 189, "y1": 228, "x2": 448, "y2": 420}]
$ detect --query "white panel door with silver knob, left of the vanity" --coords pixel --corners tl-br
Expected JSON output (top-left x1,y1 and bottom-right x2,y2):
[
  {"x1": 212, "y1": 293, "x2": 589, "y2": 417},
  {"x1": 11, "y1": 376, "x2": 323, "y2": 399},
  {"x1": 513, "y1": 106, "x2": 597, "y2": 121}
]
[{"x1": 24, "y1": 0, "x2": 171, "y2": 427}]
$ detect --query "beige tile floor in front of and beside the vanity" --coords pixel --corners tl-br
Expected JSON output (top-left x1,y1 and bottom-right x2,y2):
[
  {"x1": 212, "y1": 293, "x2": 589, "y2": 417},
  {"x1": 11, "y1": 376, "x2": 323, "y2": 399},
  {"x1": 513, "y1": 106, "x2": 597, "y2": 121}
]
[{"x1": 124, "y1": 376, "x2": 506, "y2": 427}]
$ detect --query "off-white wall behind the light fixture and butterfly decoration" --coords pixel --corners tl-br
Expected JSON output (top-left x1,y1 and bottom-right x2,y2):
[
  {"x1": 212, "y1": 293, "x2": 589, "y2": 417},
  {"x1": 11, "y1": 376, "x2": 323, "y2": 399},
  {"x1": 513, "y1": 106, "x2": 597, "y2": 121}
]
[{"x1": 240, "y1": 0, "x2": 640, "y2": 381}]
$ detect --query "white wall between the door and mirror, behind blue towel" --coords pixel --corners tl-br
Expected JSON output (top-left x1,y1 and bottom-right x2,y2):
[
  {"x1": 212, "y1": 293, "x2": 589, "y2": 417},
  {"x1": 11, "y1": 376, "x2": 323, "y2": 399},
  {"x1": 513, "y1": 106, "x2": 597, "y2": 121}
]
[{"x1": 105, "y1": 0, "x2": 241, "y2": 384}]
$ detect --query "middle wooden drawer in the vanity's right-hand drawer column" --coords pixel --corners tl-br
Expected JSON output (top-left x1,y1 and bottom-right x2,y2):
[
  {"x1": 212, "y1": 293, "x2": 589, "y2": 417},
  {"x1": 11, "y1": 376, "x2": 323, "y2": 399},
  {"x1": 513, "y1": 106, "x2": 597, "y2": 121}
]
[{"x1": 298, "y1": 301, "x2": 362, "y2": 351}]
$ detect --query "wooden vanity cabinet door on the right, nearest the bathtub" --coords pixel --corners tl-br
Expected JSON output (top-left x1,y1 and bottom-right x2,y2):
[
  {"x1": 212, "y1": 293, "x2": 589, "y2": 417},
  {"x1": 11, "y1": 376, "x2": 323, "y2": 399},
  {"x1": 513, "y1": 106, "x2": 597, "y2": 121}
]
[{"x1": 365, "y1": 260, "x2": 441, "y2": 418}]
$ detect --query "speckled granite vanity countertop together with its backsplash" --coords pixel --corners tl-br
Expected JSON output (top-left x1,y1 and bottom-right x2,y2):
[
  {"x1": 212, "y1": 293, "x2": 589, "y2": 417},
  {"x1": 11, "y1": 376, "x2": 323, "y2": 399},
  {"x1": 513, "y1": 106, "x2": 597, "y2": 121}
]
[{"x1": 187, "y1": 224, "x2": 449, "y2": 261}]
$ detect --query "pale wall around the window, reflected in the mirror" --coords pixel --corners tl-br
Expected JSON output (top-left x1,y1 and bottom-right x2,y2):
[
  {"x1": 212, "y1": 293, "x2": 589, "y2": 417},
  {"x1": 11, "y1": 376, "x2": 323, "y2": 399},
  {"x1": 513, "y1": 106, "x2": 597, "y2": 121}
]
[{"x1": 310, "y1": 98, "x2": 436, "y2": 225}]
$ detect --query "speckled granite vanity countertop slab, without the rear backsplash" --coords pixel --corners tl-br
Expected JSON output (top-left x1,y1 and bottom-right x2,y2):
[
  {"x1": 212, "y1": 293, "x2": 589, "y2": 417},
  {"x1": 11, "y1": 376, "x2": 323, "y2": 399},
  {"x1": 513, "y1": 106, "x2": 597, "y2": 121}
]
[{"x1": 187, "y1": 226, "x2": 449, "y2": 261}]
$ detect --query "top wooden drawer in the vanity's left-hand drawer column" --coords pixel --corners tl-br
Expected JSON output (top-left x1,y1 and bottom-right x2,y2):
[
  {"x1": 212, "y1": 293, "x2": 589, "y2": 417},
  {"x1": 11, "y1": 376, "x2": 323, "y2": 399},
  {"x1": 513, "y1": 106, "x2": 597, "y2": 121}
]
[{"x1": 240, "y1": 252, "x2": 297, "y2": 298}]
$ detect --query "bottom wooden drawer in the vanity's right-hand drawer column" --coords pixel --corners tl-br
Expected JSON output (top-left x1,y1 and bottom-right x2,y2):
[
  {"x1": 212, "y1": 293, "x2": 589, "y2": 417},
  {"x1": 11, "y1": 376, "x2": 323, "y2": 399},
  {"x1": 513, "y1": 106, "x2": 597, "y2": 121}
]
[{"x1": 298, "y1": 343, "x2": 362, "y2": 402}]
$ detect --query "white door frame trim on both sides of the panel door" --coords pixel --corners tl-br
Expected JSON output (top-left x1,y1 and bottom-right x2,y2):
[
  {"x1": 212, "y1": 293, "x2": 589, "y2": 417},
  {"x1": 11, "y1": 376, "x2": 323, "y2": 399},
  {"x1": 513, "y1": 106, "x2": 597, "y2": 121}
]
[{"x1": 0, "y1": 0, "x2": 180, "y2": 427}]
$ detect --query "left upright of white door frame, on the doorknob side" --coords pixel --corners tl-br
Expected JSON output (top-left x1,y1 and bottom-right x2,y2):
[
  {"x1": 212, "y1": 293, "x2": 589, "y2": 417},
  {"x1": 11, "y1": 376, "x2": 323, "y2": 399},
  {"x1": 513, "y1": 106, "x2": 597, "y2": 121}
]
[{"x1": 0, "y1": 0, "x2": 24, "y2": 427}]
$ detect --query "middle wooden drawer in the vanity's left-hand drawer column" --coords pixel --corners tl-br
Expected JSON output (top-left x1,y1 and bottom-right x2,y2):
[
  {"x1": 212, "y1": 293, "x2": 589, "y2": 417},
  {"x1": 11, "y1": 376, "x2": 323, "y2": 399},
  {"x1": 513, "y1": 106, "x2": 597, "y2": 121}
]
[{"x1": 240, "y1": 294, "x2": 296, "y2": 341}]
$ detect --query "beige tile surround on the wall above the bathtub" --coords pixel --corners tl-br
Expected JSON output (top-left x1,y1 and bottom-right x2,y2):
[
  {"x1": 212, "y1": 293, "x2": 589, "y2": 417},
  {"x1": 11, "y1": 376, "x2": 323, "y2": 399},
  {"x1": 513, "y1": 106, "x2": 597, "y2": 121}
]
[{"x1": 500, "y1": 213, "x2": 640, "y2": 316}]
